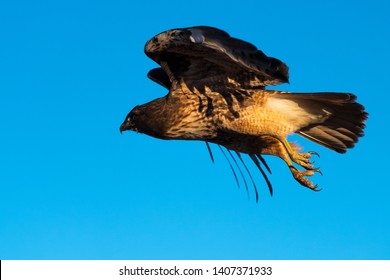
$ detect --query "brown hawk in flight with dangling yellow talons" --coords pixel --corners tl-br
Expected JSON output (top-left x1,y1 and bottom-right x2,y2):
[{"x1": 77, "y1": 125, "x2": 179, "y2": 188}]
[{"x1": 120, "y1": 26, "x2": 367, "y2": 199}]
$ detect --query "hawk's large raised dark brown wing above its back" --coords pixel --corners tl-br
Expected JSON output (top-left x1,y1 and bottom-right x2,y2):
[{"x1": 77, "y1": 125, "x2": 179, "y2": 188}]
[{"x1": 145, "y1": 26, "x2": 288, "y2": 89}]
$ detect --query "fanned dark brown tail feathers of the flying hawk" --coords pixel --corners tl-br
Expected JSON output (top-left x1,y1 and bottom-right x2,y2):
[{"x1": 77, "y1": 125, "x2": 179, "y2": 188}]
[{"x1": 292, "y1": 93, "x2": 368, "y2": 153}]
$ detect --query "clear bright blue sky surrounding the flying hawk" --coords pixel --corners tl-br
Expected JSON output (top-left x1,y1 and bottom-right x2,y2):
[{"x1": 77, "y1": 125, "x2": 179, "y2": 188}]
[{"x1": 0, "y1": 0, "x2": 390, "y2": 259}]
